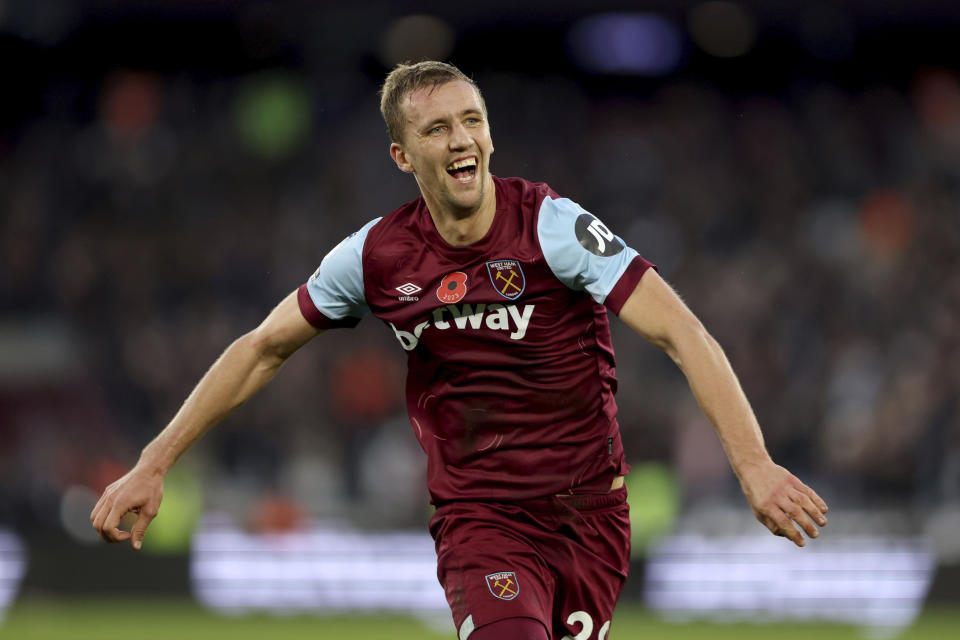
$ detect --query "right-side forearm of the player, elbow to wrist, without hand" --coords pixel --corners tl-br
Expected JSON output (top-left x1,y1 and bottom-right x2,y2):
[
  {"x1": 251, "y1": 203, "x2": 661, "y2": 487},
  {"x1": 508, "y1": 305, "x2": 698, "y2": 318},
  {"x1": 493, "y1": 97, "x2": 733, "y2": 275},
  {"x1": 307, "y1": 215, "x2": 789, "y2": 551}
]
[{"x1": 668, "y1": 322, "x2": 771, "y2": 477}]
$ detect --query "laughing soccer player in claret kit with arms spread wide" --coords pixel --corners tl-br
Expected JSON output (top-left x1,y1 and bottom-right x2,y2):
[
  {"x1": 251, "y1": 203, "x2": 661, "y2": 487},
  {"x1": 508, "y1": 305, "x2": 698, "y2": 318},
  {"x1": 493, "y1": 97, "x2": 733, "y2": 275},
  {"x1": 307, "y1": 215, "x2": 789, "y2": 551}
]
[{"x1": 91, "y1": 62, "x2": 827, "y2": 640}]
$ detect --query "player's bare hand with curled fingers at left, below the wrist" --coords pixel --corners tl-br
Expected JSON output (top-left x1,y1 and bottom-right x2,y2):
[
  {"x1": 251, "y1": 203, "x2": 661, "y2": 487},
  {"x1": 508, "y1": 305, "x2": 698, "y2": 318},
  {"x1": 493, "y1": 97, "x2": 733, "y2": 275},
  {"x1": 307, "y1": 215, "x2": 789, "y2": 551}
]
[{"x1": 90, "y1": 464, "x2": 164, "y2": 550}]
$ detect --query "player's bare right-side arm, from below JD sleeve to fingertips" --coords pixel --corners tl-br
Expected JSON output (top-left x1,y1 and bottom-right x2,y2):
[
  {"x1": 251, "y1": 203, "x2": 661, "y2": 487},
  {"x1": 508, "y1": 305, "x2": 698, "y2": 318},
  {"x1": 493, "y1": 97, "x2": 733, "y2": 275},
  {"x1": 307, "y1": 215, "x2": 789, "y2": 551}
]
[{"x1": 620, "y1": 269, "x2": 827, "y2": 547}]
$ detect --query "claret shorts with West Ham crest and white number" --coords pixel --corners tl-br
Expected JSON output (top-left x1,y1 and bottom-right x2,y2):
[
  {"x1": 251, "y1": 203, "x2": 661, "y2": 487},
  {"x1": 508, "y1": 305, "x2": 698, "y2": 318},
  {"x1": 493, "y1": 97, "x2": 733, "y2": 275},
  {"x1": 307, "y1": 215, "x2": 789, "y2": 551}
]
[{"x1": 430, "y1": 487, "x2": 630, "y2": 640}]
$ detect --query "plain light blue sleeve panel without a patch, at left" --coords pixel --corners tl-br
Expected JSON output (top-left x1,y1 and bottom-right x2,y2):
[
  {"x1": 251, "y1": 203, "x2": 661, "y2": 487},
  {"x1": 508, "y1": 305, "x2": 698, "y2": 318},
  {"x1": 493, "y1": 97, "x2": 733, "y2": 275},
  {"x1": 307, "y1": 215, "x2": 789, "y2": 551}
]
[{"x1": 307, "y1": 218, "x2": 381, "y2": 320}]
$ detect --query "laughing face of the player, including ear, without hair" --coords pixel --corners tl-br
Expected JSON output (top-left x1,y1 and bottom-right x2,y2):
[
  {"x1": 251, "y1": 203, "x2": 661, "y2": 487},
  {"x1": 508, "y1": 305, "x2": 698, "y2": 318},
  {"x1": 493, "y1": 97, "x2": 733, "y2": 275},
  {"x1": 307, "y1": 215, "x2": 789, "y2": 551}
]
[{"x1": 390, "y1": 80, "x2": 493, "y2": 218}]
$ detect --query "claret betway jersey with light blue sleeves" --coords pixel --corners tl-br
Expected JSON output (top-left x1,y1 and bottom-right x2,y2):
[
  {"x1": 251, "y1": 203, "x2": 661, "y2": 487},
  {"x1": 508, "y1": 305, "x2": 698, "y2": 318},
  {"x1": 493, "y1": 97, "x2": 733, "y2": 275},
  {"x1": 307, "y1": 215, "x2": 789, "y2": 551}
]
[{"x1": 298, "y1": 177, "x2": 651, "y2": 504}]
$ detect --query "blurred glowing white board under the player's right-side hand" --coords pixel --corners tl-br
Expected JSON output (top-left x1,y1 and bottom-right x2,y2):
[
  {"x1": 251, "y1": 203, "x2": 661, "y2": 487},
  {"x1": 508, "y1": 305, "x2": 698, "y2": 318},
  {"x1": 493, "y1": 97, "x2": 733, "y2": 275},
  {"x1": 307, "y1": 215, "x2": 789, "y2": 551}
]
[{"x1": 644, "y1": 535, "x2": 934, "y2": 629}]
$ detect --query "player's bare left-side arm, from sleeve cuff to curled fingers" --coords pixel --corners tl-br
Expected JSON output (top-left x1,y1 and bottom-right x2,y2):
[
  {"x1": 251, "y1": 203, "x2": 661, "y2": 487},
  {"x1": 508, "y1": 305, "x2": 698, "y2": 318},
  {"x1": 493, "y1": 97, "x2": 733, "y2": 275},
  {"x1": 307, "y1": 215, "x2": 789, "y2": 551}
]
[{"x1": 90, "y1": 291, "x2": 320, "y2": 549}]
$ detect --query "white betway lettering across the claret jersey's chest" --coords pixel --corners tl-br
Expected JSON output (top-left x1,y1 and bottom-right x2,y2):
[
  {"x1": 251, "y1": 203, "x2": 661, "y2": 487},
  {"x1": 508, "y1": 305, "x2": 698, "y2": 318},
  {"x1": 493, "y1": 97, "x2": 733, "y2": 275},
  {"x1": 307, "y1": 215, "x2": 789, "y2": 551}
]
[{"x1": 387, "y1": 303, "x2": 536, "y2": 351}]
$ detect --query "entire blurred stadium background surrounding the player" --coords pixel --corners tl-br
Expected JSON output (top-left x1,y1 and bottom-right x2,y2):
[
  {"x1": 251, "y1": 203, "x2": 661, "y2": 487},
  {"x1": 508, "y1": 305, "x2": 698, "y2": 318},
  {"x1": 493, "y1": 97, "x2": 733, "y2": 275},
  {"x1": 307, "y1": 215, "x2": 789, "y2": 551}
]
[{"x1": 0, "y1": 0, "x2": 960, "y2": 638}]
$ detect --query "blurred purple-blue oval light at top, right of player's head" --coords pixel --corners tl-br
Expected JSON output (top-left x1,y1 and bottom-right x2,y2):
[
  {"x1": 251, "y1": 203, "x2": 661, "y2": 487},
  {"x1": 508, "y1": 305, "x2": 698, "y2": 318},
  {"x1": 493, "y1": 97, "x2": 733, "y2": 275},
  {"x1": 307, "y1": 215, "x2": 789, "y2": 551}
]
[{"x1": 567, "y1": 13, "x2": 683, "y2": 76}]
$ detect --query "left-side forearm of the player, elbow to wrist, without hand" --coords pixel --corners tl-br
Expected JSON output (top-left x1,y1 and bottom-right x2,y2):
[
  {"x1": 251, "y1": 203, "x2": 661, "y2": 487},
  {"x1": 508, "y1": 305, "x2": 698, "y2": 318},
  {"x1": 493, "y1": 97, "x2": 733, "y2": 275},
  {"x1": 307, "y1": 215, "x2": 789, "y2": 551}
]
[{"x1": 138, "y1": 333, "x2": 285, "y2": 474}]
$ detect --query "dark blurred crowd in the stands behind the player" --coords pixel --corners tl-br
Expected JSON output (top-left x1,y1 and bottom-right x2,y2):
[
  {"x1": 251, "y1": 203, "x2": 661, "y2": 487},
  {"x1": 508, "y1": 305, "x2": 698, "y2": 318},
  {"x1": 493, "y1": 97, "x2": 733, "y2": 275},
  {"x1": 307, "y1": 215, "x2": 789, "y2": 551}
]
[{"x1": 0, "y1": 50, "x2": 960, "y2": 544}]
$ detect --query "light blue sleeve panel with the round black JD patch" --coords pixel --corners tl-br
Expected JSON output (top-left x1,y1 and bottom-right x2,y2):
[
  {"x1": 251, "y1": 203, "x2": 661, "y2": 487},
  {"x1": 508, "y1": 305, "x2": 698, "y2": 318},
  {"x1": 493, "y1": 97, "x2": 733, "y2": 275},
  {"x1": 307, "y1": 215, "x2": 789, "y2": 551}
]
[{"x1": 537, "y1": 196, "x2": 637, "y2": 304}]
